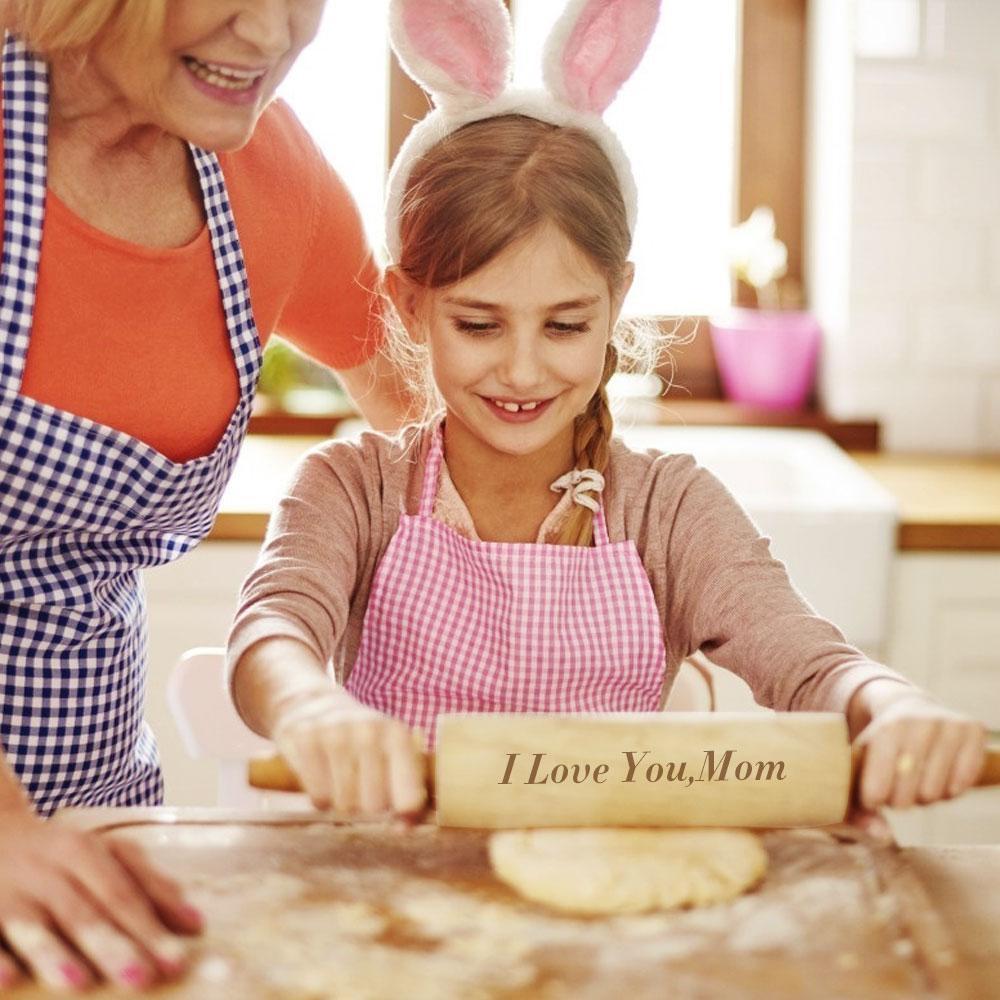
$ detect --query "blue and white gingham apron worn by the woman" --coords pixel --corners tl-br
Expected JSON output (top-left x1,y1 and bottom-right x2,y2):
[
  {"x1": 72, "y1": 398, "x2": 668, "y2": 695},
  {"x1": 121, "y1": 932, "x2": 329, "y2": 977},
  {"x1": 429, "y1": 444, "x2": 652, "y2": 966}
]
[{"x1": 0, "y1": 36, "x2": 260, "y2": 814}]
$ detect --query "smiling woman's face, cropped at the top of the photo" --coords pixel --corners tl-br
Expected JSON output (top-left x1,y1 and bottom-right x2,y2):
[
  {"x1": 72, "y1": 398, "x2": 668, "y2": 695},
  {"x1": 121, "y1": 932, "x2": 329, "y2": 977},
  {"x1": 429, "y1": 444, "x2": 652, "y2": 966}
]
[{"x1": 92, "y1": 0, "x2": 326, "y2": 151}]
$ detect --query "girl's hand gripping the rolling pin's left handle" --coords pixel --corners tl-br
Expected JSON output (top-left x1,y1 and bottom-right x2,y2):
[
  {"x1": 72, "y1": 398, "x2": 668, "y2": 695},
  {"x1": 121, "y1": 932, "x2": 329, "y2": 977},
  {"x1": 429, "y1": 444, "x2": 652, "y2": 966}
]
[{"x1": 271, "y1": 684, "x2": 427, "y2": 818}]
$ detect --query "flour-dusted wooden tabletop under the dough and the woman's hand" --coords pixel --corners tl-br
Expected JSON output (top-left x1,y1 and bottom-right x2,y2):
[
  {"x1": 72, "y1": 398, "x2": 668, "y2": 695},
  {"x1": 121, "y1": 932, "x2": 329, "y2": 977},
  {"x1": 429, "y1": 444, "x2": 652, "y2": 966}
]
[{"x1": 43, "y1": 809, "x2": 1000, "y2": 1000}]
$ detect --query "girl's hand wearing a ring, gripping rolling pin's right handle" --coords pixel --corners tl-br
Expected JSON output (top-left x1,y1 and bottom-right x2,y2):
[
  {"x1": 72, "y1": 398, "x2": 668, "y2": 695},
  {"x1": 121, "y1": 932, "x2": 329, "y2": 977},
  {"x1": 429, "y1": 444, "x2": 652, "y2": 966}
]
[{"x1": 854, "y1": 689, "x2": 987, "y2": 825}]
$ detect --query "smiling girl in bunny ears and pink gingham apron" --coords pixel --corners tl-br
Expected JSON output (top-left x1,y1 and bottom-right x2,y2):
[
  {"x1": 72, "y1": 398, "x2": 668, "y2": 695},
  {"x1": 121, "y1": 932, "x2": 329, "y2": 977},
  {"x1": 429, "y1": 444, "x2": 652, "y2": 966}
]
[{"x1": 229, "y1": 0, "x2": 985, "y2": 828}]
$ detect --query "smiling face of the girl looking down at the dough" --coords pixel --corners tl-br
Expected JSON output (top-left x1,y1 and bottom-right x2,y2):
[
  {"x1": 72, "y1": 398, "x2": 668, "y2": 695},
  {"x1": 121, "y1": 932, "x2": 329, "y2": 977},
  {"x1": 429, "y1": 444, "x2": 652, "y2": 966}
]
[{"x1": 402, "y1": 223, "x2": 624, "y2": 456}]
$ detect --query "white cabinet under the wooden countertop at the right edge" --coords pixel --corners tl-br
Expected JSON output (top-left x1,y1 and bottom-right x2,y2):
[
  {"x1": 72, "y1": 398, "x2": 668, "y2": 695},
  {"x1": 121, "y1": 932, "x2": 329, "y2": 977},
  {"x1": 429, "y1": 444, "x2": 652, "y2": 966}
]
[{"x1": 886, "y1": 552, "x2": 1000, "y2": 844}]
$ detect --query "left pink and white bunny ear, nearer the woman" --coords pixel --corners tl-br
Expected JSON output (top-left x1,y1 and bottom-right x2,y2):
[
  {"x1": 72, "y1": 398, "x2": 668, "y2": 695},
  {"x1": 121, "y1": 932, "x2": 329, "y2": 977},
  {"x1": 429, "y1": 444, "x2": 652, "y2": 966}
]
[{"x1": 389, "y1": 0, "x2": 514, "y2": 107}]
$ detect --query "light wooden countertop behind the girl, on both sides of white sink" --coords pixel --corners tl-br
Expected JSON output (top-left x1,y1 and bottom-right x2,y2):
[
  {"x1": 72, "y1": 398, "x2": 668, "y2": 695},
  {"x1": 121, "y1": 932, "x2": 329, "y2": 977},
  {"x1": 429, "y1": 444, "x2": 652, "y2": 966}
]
[{"x1": 209, "y1": 434, "x2": 1000, "y2": 552}]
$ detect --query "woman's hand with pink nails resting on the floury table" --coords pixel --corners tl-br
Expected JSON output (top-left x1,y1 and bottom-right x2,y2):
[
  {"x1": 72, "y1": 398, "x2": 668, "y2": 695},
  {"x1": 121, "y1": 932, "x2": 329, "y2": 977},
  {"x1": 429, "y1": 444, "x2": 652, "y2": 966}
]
[{"x1": 0, "y1": 804, "x2": 202, "y2": 992}]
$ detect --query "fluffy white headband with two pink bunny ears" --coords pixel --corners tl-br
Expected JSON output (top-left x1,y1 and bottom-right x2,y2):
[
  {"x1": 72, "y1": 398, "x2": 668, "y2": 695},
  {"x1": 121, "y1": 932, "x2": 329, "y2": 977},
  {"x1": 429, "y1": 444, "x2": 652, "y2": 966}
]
[{"x1": 386, "y1": 0, "x2": 660, "y2": 263}]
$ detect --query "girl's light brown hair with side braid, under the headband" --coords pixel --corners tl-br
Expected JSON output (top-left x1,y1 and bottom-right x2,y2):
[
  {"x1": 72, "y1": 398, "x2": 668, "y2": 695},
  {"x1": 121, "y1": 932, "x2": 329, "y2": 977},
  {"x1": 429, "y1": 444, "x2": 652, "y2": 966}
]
[{"x1": 386, "y1": 115, "x2": 664, "y2": 545}]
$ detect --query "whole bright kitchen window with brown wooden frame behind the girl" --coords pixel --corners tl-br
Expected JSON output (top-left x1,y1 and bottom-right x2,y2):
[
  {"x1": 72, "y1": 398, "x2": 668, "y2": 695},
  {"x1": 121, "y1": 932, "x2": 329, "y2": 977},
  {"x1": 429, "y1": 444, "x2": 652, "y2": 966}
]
[{"x1": 272, "y1": 0, "x2": 805, "y2": 406}]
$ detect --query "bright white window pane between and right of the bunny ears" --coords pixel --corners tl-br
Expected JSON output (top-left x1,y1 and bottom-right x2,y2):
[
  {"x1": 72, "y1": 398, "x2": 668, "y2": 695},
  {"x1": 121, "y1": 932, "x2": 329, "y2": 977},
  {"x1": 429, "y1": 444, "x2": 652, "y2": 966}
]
[{"x1": 514, "y1": 0, "x2": 739, "y2": 315}]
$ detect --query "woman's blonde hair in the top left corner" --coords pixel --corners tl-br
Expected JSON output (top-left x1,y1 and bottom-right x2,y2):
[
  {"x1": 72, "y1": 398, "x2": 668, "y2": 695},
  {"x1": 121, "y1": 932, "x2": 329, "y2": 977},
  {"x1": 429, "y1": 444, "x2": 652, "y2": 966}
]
[{"x1": 0, "y1": 0, "x2": 167, "y2": 56}]
